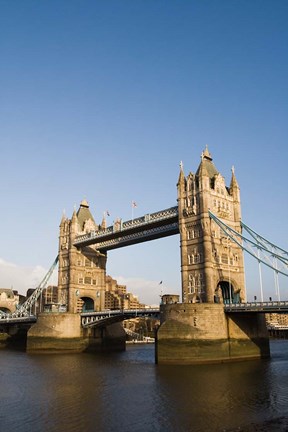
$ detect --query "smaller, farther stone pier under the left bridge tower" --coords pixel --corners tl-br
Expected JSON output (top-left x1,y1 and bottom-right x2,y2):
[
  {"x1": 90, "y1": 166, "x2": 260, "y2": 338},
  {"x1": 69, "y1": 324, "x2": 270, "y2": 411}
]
[{"x1": 27, "y1": 313, "x2": 125, "y2": 353}]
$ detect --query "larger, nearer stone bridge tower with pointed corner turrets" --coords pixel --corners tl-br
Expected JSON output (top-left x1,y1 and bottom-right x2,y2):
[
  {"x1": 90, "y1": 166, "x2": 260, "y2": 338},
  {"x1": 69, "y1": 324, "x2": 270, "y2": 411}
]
[{"x1": 177, "y1": 147, "x2": 246, "y2": 303}]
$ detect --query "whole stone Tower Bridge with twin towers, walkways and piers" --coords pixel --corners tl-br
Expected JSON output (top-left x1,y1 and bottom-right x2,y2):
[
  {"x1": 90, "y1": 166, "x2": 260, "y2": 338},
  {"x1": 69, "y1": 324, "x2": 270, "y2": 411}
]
[{"x1": 0, "y1": 147, "x2": 288, "y2": 363}]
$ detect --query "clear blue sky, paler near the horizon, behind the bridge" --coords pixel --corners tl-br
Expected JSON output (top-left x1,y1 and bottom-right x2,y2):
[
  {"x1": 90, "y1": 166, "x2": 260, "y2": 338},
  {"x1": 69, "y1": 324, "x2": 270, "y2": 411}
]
[{"x1": 0, "y1": 0, "x2": 288, "y2": 303}]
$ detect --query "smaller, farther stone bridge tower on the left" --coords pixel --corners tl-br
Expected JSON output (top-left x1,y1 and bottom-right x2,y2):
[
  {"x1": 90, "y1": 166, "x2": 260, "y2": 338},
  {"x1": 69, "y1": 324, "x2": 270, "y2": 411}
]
[{"x1": 58, "y1": 200, "x2": 107, "y2": 313}]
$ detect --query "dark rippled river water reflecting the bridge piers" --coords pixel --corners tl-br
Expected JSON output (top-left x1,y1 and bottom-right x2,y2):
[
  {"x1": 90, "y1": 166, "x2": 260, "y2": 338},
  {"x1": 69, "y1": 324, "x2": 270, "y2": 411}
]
[{"x1": 0, "y1": 340, "x2": 288, "y2": 432}]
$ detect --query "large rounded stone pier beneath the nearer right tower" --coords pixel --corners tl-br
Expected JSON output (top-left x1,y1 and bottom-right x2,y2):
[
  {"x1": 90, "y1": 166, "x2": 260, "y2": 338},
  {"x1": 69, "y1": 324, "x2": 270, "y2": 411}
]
[{"x1": 156, "y1": 303, "x2": 270, "y2": 364}]
